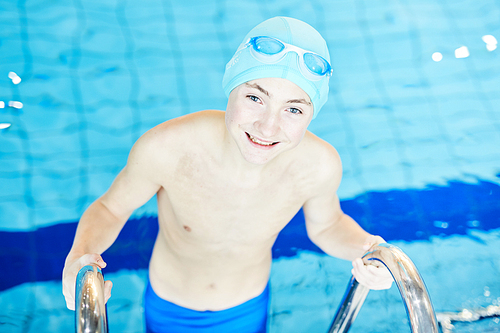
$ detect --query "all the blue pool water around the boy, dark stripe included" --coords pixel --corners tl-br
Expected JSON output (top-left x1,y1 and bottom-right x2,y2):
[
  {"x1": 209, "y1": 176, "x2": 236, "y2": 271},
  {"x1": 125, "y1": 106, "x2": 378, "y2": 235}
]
[{"x1": 0, "y1": 0, "x2": 500, "y2": 333}]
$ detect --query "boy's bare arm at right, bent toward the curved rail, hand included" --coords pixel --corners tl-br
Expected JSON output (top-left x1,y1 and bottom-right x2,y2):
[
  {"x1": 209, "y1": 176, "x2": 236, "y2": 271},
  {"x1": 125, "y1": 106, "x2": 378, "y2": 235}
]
[{"x1": 303, "y1": 148, "x2": 393, "y2": 289}]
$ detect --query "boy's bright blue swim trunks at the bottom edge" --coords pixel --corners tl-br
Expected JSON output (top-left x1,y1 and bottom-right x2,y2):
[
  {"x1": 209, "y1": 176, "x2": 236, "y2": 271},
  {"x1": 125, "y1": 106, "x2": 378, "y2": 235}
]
[{"x1": 144, "y1": 281, "x2": 269, "y2": 333}]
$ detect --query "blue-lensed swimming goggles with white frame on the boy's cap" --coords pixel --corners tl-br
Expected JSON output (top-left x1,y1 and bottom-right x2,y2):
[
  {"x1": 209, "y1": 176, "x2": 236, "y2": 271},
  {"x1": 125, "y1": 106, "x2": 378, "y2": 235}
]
[{"x1": 245, "y1": 36, "x2": 333, "y2": 81}]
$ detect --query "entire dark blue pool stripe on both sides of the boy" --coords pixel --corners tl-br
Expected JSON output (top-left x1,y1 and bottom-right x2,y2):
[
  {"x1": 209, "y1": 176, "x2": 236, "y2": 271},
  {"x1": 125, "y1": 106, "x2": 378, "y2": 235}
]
[{"x1": 0, "y1": 181, "x2": 500, "y2": 290}]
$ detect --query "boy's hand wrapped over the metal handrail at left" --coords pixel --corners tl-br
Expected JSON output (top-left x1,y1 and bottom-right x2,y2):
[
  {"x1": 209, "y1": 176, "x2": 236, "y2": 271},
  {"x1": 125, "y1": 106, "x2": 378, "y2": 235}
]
[{"x1": 62, "y1": 253, "x2": 113, "y2": 311}]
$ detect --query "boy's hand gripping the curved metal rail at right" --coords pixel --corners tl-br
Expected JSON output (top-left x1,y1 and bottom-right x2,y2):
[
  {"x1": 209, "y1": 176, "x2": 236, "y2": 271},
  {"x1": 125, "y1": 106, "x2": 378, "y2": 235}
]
[{"x1": 352, "y1": 235, "x2": 394, "y2": 290}]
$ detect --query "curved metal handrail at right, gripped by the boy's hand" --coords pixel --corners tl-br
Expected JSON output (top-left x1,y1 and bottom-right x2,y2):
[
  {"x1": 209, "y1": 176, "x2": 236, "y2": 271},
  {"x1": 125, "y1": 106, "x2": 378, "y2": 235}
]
[{"x1": 328, "y1": 243, "x2": 439, "y2": 333}]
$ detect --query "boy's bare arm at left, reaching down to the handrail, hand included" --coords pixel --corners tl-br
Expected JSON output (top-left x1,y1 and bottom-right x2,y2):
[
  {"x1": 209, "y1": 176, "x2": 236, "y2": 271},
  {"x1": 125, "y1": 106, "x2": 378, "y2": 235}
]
[{"x1": 63, "y1": 129, "x2": 160, "y2": 310}]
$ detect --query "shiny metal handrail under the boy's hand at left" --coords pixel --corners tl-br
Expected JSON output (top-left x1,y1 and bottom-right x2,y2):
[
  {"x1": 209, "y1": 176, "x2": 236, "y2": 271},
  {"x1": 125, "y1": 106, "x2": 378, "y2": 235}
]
[{"x1": 75, "y1": 265, "x2": 108, "y2": 333}]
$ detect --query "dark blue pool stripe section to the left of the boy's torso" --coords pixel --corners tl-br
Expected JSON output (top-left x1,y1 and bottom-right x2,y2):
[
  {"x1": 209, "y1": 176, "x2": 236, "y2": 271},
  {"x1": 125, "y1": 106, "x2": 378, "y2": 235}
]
[{"x1": 0, "y1": 217, "x2": 158, "y2": 290}]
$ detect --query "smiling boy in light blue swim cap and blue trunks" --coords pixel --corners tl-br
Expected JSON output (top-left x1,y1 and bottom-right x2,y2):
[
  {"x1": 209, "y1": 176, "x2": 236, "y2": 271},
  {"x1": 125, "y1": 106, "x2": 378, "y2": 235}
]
[{"x1": 63, "y1": 17, "x2": 392, "y2": 333}]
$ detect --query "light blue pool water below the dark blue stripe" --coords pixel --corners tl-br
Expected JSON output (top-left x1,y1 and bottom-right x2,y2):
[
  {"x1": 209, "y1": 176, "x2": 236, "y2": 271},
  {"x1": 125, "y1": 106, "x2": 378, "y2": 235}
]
[{"x1": 0, "y1": 230, "x2": 500, "y2": 333}]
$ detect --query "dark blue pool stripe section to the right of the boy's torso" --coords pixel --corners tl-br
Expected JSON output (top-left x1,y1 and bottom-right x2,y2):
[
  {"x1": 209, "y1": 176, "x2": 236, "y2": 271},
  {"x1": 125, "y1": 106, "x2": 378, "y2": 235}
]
[{"x1": 273, "y1": 181, "x2": 500, "y2": 253}]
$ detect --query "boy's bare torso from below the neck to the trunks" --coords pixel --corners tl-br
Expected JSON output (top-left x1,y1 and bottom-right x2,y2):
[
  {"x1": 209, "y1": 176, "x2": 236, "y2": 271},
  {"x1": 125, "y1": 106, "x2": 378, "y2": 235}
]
[{"x1": 145, "y1": 112, "x2": 328, "y2": 311}]
